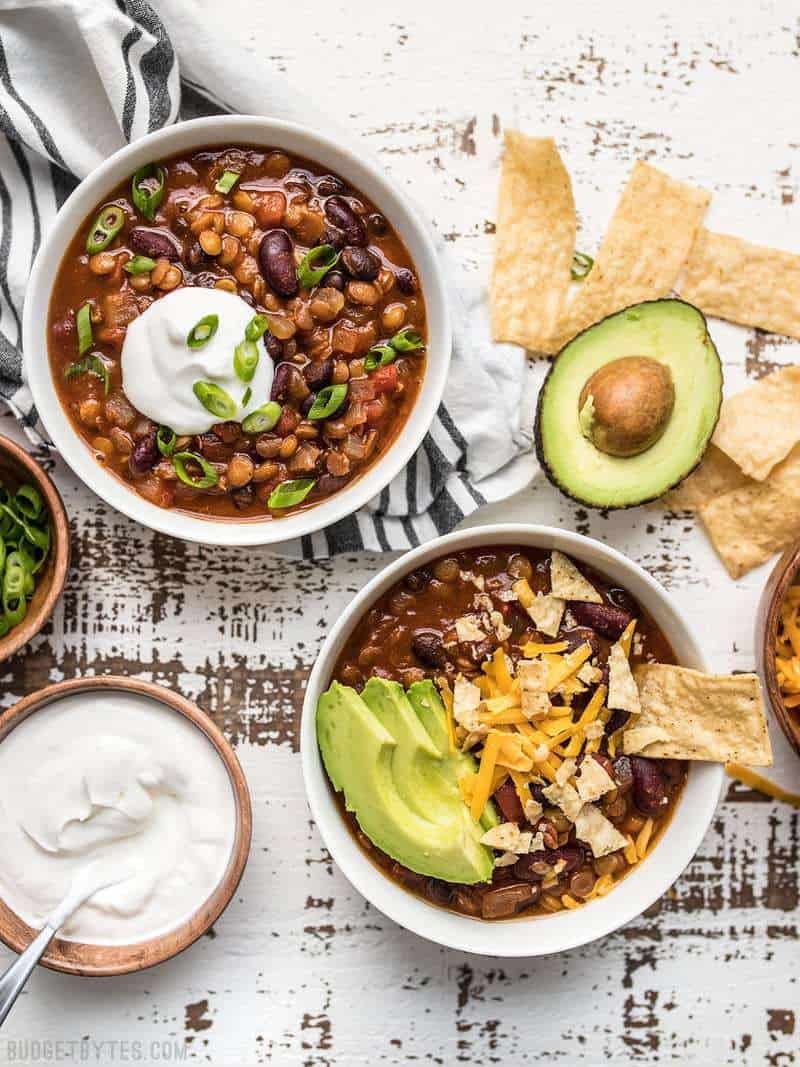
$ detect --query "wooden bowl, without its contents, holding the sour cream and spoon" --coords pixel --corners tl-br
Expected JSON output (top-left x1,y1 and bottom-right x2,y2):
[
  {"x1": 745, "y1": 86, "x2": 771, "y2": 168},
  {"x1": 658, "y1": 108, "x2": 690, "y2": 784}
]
[{"x1": 0, "y1": 675, "x2": 253, "y2": 976}]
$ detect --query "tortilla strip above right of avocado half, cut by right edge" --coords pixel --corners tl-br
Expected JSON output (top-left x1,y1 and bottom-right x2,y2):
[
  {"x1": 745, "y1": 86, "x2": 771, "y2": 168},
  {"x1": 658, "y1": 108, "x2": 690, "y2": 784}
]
[{"x1": 681, "y1": 229, "x2": 800, "y2": 339}]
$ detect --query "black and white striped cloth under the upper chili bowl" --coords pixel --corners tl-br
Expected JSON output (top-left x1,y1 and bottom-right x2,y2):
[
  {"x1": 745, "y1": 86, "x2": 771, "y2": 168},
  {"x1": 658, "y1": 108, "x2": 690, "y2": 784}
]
[{"x1": 0, "y1": 0, "x2": 533, "y2": 558}]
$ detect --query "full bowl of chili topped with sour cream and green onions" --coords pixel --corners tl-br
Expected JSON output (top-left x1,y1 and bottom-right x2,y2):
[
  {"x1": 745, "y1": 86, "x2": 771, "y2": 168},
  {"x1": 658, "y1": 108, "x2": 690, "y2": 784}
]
[{"x1": 23, "y1": 115, "x2": 451, "y2": 545}]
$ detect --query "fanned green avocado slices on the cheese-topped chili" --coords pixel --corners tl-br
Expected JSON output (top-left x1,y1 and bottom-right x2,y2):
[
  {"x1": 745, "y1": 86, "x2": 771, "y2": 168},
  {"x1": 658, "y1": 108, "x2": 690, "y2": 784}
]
[{"x1": 317, "y1": 679, "x2": 494, "y2": 885}]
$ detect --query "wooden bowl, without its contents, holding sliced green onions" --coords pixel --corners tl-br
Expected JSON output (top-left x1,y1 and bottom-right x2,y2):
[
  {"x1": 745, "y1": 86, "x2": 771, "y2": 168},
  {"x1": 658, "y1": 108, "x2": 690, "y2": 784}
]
[{"x1": 0, "y1": 435, "x2": 69, "y2": 663}]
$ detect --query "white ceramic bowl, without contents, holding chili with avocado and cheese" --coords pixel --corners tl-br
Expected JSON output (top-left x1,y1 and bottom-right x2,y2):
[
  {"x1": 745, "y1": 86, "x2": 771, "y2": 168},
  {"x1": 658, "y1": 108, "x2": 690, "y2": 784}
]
[{"x1": 301, "y1": 524, "x2": 722, "y2": 956}]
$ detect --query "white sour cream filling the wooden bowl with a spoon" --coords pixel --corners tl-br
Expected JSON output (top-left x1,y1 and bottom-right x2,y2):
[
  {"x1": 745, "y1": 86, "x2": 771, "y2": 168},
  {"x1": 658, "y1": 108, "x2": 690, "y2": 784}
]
[{"x1": 0, "y1": 691, "x2": 236, "y2": 944}]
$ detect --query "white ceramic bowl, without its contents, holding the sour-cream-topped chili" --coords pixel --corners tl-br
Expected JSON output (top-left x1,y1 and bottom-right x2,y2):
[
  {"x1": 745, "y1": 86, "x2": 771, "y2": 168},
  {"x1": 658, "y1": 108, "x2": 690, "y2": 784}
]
[{"x1": 22, "y1": 115, "x2": 451, "y2": 545}]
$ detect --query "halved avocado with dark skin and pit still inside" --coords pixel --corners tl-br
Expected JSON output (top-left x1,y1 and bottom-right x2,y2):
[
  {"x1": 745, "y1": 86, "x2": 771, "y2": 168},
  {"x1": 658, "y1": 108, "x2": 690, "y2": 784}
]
[{"x1": 534, "y1": 299, "x2": 722, "y2": 509}]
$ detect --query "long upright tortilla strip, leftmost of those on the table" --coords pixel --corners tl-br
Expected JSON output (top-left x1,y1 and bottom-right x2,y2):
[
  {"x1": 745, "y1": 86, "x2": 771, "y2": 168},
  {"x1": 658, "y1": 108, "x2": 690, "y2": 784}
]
[{"x1": 490, "y1": 130, "x2": 577, "y2": 352}]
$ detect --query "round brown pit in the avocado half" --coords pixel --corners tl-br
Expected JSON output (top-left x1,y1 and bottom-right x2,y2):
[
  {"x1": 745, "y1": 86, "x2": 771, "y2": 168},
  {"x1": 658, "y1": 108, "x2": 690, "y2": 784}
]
[{"x1": 578, "y1": 355, "x2": 675, "y2": 457}]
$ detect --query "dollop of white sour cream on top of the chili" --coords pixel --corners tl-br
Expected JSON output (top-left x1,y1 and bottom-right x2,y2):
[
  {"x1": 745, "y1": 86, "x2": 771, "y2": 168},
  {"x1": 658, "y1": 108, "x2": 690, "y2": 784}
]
[{"x1": 122, "y1": 286, "x2": 273, "y2": 433}]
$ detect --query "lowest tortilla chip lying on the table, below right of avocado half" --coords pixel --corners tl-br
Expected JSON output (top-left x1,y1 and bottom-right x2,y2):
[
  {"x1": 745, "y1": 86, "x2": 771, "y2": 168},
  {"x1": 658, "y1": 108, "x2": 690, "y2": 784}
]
[{"x1": 700, "y1": 445, "x2": 800, "y2": 578}]
